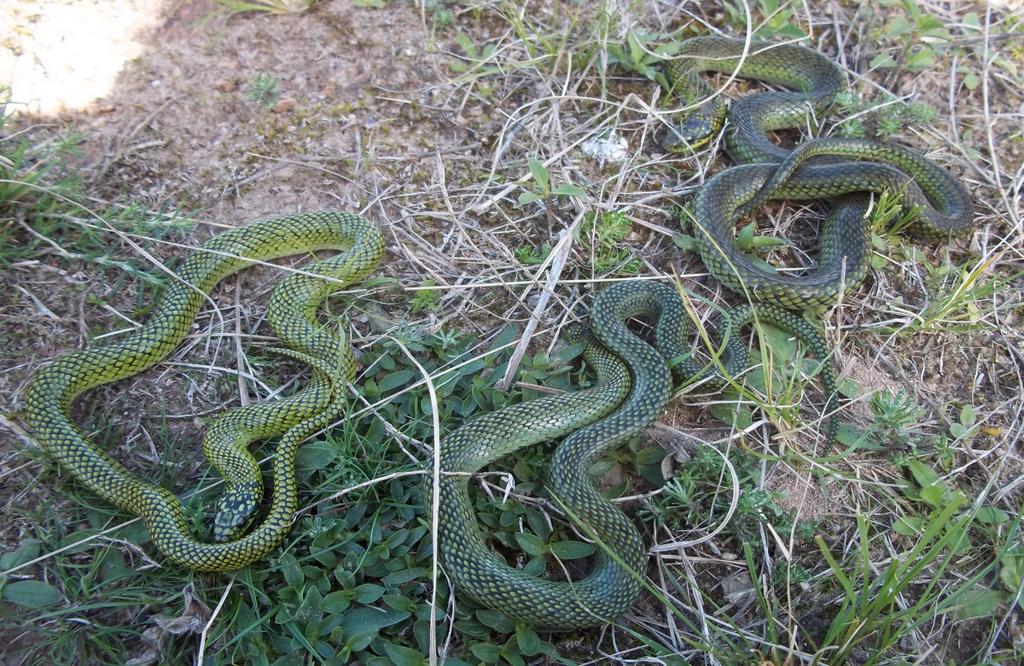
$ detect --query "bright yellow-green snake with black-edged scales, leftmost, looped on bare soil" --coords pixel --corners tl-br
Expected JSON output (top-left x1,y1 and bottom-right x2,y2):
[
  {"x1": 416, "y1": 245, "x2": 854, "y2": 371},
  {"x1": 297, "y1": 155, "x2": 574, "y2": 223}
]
[{"x1": 25, "y1": 212, "x2": 384, "y2": 571}]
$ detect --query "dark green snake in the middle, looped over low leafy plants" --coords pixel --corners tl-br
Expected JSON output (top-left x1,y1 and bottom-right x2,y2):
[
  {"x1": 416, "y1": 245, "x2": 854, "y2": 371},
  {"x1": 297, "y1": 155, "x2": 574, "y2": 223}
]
[{"x1": 438, "y1": 281, "x2": 838, "y2": 630}]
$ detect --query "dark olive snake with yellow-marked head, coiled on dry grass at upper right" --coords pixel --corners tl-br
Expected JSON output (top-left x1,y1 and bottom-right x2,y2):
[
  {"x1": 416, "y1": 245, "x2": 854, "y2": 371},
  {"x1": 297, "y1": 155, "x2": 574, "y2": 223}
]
[{"x1": 664, "y1": 37, "x2": 973, "y2": 309}]
